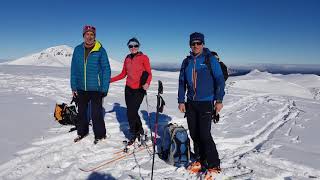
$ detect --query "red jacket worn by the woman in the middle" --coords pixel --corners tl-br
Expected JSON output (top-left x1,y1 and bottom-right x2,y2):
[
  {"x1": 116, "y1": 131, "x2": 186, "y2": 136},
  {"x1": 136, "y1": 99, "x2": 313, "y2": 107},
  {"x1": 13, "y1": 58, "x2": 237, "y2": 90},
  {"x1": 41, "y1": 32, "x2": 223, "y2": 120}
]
[{"x1": 110, "y1": 52, "x2": 152, "y2": 89}]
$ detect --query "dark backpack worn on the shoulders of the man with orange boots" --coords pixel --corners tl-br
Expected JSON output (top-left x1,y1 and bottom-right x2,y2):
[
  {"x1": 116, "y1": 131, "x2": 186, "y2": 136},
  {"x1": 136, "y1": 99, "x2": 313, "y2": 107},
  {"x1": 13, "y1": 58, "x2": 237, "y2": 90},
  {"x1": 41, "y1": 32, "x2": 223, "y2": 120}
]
[{"x1": 182, "y1": 51, "x2": 229, "y2": 81}]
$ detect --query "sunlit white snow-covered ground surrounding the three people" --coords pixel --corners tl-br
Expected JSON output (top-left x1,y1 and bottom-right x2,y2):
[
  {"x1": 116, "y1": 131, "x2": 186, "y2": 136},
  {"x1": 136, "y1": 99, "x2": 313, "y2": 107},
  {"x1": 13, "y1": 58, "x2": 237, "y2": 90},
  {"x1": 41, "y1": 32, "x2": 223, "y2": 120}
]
[{"x1": 0, "y1": 65, "x2": 320, "y2": 180}]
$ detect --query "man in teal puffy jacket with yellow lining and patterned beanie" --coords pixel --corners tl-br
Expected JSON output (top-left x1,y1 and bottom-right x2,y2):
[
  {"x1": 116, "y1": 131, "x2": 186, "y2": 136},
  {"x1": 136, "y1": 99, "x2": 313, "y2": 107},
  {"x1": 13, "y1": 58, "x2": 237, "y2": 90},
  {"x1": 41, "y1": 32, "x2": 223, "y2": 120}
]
[{"x1": 70, "y1": 25, "x2": 111, "y2": 144}]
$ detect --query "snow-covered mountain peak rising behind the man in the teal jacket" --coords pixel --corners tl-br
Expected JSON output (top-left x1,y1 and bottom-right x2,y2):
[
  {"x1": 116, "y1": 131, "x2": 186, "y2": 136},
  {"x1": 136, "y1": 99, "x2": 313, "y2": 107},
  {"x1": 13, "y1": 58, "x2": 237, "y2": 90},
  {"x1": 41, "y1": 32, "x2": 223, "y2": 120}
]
[{"x1": 4, "y1": 45, "x2": 122, "y2": 71}]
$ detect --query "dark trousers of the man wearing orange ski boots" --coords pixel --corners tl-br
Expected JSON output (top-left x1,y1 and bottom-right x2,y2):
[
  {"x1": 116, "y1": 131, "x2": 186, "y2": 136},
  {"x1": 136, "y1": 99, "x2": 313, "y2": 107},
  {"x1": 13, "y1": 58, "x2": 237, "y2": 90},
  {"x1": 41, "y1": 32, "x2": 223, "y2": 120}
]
[{"x1": 186, "y1": 101, "x2": 220, "y2": 168}]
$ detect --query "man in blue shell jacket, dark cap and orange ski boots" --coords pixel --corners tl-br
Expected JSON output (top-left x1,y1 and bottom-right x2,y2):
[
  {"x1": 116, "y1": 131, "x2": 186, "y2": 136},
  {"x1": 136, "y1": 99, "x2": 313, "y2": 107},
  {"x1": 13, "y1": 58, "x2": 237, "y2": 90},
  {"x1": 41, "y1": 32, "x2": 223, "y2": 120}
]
[{"x1": 178, "y1": 32, "x2": 225, "y2": 176}]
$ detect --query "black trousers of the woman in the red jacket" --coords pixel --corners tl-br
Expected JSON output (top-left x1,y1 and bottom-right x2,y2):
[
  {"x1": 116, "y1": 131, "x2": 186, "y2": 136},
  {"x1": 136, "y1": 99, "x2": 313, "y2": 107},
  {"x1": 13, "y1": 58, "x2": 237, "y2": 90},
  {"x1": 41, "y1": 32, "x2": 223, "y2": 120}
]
[{"x1": 125, "y1": 86, "x2": 144, "y2": 137}]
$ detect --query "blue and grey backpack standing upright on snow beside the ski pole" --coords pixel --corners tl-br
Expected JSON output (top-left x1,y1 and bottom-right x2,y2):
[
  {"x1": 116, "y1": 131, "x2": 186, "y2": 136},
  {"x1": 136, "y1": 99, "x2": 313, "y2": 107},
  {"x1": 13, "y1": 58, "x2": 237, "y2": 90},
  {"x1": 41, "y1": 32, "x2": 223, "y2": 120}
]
[{"x1": 159, "y1": 123, "x2": 190, "y2": 167}]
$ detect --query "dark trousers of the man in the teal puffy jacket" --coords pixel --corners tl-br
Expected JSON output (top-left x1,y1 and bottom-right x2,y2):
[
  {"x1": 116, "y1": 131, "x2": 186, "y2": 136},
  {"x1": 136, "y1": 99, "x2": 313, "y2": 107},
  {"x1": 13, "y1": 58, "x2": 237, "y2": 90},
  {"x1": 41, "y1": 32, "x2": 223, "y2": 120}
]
[{"x1": 77, "y1": 91, "x2": 106, "y2": 139}]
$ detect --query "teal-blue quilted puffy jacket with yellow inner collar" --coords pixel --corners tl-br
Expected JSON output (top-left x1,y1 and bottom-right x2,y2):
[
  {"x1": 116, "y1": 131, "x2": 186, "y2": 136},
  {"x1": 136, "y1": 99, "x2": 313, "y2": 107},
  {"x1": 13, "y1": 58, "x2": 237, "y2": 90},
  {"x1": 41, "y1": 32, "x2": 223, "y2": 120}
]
[{"x1": 70, "y1": 41, "x2": 111, "y2": 93}]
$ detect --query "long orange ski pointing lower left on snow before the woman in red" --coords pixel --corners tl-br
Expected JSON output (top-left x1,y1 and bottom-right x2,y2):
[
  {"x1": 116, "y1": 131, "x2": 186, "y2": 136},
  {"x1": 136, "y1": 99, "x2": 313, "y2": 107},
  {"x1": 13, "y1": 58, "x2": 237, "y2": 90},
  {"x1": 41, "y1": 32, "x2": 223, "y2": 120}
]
[{"x1": 79, "y1": 145, "x2": 151, "y2": 172}]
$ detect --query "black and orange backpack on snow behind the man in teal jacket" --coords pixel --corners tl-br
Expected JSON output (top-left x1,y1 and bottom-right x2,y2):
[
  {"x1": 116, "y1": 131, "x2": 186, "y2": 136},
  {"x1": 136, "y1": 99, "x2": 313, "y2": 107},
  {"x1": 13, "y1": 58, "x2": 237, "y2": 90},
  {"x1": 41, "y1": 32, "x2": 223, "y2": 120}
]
[{"x1": 54, "y1": 99, "x2": 78, "y2": 126}]
